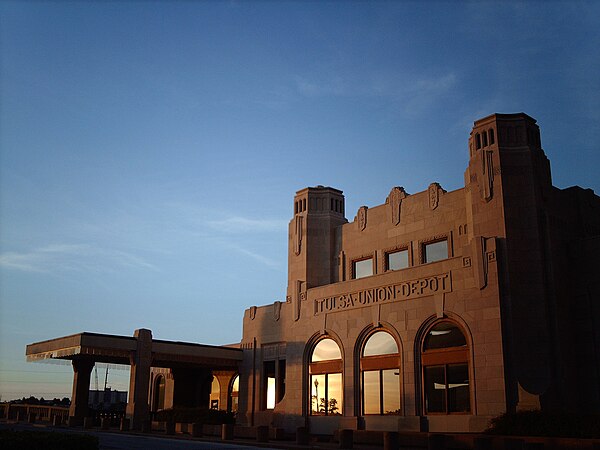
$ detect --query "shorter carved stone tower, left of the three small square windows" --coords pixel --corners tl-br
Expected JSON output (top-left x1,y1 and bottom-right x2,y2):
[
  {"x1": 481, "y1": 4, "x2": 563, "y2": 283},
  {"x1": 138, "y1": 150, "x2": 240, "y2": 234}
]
[{"x1": 287, "y1": 186, "x2": 347, "y2": 320}]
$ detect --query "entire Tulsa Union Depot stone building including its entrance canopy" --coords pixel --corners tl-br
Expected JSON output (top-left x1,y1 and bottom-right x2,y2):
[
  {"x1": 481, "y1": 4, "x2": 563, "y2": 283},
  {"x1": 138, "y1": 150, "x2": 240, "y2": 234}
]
[{"x1": 27, "y1": 113, "x2": 600, "y2": 433}]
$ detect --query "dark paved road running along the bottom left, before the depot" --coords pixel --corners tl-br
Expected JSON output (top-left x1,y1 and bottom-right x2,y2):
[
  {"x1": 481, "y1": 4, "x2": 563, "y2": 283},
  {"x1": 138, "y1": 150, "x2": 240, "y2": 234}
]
[{"x1": 0, "y1": 423, "x2": 284, "y2": 450}]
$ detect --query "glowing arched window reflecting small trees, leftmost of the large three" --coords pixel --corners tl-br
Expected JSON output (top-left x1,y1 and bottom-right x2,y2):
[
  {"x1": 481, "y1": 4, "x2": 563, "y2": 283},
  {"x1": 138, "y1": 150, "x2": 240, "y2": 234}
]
[{"x1": 309, "y1": 338, "x2": 343, "y2": 416}]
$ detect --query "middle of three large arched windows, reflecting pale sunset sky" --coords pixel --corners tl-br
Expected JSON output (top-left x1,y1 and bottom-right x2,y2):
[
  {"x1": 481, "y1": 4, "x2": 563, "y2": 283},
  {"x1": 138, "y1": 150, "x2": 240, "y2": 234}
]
[{"x1": 360, "y1": 331, "x2": 400, "y2": 414}]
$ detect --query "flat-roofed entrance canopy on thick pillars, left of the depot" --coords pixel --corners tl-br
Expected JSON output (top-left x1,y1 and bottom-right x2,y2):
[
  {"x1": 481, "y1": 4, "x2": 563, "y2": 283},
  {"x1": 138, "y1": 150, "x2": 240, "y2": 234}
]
[{"x1": 25, "y1": 329, "x2": 243, "y2": 429}]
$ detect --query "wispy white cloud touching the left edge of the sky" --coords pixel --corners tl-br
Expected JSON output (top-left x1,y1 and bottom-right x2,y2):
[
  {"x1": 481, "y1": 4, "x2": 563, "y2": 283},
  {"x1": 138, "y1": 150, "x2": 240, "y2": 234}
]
[{"x1": 0, "y1": 244, "x2": 158, "y2": 273}]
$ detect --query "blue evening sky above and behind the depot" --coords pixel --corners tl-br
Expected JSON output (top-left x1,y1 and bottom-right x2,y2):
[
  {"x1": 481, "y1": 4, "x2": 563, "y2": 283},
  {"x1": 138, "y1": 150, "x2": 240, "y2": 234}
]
[{"x1": 0, "y1": 1, "x2": 600, "y2": 400}]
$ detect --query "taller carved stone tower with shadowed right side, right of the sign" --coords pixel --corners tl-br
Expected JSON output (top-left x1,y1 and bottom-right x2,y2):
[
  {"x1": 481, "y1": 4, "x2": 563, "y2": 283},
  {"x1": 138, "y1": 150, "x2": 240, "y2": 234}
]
[{"x1": 465, "y1": 113, "x2": 553, "y2": 408}]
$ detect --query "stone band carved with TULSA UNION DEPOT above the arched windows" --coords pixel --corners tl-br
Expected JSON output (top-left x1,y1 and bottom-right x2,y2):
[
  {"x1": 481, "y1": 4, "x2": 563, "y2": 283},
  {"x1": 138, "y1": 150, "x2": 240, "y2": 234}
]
[{"x1": 314, "y1": 272, "x2": 452, "y2": 315}]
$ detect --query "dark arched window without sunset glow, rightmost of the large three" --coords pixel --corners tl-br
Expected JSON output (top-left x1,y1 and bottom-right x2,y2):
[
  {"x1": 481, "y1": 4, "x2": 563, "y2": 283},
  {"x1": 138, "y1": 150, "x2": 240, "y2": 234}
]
[{"x1": 421, "y1": 320, "x2": 471, "y2": 414}]
